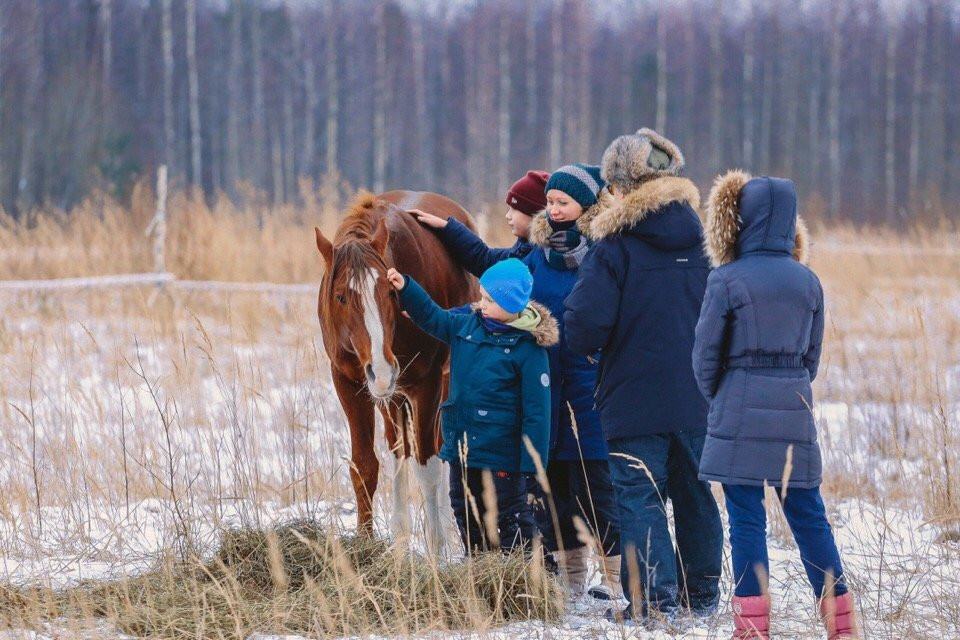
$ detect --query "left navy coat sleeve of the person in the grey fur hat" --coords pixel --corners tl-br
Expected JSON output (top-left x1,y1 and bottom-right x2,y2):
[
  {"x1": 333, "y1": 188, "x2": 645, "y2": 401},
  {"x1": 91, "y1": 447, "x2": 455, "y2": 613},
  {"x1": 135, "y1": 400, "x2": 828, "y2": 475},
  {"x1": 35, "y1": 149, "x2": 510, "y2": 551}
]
[{"x1": 563, "y1": 241, "x2": 625, "y2": 356}]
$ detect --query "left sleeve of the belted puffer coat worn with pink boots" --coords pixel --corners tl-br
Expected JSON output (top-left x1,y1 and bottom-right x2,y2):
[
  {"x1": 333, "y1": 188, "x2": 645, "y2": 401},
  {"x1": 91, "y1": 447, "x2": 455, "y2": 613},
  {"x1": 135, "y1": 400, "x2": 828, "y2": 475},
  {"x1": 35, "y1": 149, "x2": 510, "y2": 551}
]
[{"x1": 693, "y1": 271, "x2": 731, "y2": 400}]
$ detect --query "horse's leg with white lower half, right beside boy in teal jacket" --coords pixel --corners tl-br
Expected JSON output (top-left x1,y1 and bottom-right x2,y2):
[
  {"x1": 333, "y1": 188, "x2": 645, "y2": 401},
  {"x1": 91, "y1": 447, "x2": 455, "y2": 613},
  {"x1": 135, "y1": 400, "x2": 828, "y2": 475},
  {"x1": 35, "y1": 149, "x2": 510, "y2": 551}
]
[{"x1": 413, "y1": 376, "x2": 448, "y2": 553}]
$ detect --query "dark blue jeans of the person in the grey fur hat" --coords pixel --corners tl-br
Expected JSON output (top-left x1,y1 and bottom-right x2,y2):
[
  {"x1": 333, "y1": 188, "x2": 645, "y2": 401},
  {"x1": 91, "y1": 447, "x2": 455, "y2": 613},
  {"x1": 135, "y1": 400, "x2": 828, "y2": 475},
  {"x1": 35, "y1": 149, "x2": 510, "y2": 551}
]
[{"x1": 608, "y1": 432, "x2": 723, "y2": 616}]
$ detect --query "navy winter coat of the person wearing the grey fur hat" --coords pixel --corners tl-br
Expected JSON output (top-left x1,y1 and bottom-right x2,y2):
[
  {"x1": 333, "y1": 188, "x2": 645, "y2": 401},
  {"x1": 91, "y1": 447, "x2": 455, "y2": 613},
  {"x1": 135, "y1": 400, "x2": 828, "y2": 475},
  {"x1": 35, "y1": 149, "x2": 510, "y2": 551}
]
[{"x1": 564, "y1": 176, "x2": 710, "y2": 439}]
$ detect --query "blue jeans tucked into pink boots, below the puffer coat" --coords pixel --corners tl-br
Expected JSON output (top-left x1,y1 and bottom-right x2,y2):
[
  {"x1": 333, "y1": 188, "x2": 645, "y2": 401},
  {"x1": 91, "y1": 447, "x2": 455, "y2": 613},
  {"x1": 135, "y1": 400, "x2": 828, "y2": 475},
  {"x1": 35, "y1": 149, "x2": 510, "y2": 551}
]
[{"x1": 723, "y1": 484, "x2": 847, "y2": 598}]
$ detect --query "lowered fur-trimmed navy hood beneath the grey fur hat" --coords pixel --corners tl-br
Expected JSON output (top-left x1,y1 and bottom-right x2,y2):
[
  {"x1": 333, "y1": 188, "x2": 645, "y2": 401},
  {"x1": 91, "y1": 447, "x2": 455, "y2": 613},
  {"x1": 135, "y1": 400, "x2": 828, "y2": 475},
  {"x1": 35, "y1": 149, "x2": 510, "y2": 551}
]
[{"x1": 580, "y1": 176, "x2": 702, "y2": 250}]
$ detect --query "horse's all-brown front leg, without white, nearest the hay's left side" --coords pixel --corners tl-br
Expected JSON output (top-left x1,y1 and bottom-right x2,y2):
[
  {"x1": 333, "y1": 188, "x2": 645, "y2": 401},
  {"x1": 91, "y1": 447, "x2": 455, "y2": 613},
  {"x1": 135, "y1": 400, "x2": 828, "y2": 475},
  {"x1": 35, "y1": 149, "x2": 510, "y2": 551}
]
[{"x1": 333, "y1": 372, "x2": 380, "y2": 534}]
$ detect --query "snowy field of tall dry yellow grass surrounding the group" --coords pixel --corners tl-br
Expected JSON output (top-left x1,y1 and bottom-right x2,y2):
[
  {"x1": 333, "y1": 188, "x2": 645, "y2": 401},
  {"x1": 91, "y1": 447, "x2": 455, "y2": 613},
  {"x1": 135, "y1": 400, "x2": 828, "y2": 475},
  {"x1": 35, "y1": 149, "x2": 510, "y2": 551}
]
[{"x1": 0, "y1": 190, "x2": 960, "y2": 639}]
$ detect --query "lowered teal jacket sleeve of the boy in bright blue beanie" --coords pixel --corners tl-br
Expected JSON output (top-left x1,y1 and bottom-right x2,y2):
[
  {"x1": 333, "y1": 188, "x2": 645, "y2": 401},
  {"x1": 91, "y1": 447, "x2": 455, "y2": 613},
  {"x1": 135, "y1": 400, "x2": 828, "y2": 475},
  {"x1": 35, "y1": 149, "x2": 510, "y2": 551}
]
[{"x1": 520, "y1": 347, "x2": 550, "y2": 473}]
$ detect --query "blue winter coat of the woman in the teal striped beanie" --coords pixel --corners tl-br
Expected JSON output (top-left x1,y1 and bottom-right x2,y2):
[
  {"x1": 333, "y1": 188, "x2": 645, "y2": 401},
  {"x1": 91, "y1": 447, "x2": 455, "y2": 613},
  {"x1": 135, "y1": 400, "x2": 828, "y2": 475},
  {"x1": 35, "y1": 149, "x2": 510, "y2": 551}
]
[{"x1": 440, "y1": 215, "x2": 609, "y2": 460}]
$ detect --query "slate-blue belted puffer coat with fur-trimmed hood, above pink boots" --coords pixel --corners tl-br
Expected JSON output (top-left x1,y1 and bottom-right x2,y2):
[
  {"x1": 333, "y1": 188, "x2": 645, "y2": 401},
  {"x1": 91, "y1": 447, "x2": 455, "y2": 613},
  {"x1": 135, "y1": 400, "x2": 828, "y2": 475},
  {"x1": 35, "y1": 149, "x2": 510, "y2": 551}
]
[{"x1": 694, "y1": 171, "x2": 823, "y2": 489}]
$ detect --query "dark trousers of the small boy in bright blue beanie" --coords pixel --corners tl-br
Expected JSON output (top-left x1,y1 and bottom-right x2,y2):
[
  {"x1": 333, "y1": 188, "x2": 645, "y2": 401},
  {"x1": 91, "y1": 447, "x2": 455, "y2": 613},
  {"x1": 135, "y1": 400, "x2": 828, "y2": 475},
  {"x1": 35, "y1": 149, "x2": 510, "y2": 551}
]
[{"x1": 450, "y1": 461, "x2": 537, "y2": 554}]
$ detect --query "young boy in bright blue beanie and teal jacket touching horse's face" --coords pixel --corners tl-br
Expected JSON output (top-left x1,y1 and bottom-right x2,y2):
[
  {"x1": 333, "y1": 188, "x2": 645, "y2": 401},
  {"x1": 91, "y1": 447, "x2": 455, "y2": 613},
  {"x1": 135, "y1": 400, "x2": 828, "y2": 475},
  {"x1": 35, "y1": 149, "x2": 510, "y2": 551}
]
[{"x1": 387, "y1": 258, "x2": 558, "y2": 554}]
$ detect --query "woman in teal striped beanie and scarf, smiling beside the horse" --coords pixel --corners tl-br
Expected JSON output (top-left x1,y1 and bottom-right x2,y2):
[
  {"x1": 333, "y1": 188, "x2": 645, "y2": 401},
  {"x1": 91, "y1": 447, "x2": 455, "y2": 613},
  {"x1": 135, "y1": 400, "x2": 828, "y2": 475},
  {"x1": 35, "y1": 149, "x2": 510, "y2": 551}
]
[{"x1": 408, "y1": 164, "x2": 621, "y2": 600}]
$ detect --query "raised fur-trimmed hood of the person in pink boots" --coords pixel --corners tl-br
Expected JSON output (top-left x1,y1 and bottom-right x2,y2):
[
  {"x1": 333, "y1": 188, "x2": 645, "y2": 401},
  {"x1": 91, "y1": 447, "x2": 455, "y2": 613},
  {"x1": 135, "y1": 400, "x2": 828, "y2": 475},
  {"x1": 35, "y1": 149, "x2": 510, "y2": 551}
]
[{"x1": 704, "y1": 169, "x2": 809, "y2": 267}]
